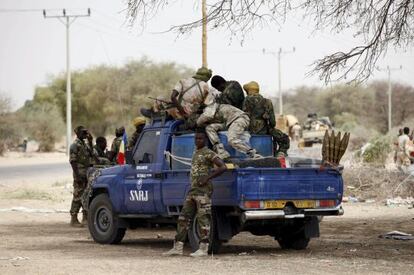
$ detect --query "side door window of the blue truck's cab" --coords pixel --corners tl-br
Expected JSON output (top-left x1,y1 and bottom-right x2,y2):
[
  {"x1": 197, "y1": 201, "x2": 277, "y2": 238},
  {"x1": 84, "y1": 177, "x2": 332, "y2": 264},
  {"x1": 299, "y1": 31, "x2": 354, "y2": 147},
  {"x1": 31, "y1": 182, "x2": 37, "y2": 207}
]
[{"x1": 134, "y1": 131, "x2": 160, "y2": 164}]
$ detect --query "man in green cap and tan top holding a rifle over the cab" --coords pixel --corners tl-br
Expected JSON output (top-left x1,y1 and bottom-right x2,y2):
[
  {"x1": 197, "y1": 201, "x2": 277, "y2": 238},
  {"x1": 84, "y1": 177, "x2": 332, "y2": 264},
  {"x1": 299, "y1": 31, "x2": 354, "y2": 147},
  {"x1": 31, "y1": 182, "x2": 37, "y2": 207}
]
[{"x1": 141, "y1": 67, "x2": 212, "y2": 119}]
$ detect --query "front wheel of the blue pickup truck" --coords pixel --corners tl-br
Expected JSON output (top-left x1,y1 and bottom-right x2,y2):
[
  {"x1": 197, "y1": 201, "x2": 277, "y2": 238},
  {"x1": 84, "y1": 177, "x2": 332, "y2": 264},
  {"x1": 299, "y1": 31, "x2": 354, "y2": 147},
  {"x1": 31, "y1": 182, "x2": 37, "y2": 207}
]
[{"x1": 88, "y1": 194, "x2": 126, "y2": 244}]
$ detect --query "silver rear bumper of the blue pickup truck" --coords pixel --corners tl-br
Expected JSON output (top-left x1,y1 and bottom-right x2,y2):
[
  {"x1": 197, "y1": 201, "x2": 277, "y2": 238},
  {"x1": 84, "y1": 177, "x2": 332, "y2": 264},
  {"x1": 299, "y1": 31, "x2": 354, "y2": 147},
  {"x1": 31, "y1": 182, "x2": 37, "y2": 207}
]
[{"x1": 242, "y1": 205, "x2": 344, "y2": 221}]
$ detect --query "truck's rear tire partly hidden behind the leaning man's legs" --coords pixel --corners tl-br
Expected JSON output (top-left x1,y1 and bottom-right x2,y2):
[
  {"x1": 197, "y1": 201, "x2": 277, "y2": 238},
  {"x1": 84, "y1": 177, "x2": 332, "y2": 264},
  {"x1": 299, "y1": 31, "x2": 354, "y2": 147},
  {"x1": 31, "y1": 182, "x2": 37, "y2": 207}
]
[{"x1": 188, "y1": 210, "x2": 222, "y2": 254}]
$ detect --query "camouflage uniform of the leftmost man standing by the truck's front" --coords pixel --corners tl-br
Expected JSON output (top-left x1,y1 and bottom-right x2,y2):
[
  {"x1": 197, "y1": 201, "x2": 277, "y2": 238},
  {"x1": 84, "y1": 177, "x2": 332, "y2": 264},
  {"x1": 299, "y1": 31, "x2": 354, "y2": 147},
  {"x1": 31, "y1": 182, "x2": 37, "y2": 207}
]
[{"x1": 69, "y1": 138, "x2": 92, "y2": 215}]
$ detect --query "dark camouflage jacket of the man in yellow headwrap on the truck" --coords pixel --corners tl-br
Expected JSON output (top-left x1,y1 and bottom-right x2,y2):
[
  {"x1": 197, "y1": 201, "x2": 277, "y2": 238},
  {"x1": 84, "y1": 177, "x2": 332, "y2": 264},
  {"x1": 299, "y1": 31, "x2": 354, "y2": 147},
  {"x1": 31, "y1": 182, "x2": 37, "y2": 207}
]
[{"x1": 243, "y1": 95, "x2": 276, "y2": 134}]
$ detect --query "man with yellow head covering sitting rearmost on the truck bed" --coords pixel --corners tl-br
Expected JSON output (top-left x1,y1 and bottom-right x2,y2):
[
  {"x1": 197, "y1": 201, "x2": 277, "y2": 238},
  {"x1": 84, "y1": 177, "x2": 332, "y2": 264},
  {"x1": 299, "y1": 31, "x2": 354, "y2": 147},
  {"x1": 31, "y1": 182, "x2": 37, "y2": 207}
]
[{"x1": 243, "y1": 81, "x2": 290, "y2": 157}]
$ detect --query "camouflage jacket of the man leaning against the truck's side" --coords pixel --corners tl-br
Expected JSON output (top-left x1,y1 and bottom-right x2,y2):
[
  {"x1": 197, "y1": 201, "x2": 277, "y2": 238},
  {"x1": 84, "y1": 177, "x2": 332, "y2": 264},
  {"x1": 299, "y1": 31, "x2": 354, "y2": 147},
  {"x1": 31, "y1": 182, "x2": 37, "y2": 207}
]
[{"x1": 190, "y1": 147, "x2": 218, "y2": 195}]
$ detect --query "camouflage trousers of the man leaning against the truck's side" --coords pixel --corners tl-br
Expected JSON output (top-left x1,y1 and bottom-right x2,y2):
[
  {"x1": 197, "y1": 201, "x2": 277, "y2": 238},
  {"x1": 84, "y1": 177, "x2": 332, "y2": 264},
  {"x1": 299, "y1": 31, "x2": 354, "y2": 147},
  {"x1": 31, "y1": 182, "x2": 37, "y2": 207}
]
[{"x1": 175, "y1": 193, "x2": 211, "y2": 243}]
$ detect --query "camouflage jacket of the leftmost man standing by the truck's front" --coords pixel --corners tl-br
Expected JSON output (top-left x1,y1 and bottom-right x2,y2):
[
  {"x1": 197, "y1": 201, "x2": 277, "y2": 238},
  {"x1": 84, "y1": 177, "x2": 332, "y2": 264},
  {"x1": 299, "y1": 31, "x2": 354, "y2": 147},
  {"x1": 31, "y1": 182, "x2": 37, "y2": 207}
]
[{"x1": 69, "y1": 138, "x2": 93, "y2": 176}]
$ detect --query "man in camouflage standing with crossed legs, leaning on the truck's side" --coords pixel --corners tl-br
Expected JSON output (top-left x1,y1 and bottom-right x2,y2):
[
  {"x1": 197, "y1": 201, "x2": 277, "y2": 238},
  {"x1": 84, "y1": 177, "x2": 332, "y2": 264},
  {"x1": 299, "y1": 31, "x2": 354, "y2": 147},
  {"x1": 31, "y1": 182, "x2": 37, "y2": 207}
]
[{"x1": 164, "y1": 131, "x2": 227, "y2": 257}]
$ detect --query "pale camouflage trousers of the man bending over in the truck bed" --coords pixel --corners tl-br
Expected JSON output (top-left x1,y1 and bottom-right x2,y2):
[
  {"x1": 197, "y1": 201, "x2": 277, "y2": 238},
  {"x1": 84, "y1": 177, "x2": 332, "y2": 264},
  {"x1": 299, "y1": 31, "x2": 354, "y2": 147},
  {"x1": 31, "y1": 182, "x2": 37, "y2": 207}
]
[{"x1": 206, "y1": 115, "x2": 252, "y2": 158}]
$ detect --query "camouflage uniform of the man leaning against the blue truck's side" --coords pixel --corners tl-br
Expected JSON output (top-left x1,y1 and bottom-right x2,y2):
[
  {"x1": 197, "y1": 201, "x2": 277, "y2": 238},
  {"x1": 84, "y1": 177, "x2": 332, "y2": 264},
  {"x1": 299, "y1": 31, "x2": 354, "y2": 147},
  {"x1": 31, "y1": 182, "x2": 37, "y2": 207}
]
[{"x1": 175, "y1": 147, "x2": 217, "y2": 245}]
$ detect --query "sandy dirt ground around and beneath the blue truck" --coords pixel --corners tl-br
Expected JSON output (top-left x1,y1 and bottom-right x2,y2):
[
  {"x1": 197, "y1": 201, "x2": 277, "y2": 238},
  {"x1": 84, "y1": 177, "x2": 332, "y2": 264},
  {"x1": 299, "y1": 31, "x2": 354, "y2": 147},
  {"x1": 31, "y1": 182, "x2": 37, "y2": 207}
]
[{"x1": 0, "y1": 152, "x2": 414, "y2": 274}]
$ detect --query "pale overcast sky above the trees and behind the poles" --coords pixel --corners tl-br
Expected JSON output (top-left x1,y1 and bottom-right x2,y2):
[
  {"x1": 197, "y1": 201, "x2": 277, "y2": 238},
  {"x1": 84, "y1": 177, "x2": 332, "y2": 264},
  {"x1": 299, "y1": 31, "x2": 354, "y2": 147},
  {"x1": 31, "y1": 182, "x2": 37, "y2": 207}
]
[{"x1": 0, "y1": 0, "x2": 414, "y2": 108}]
